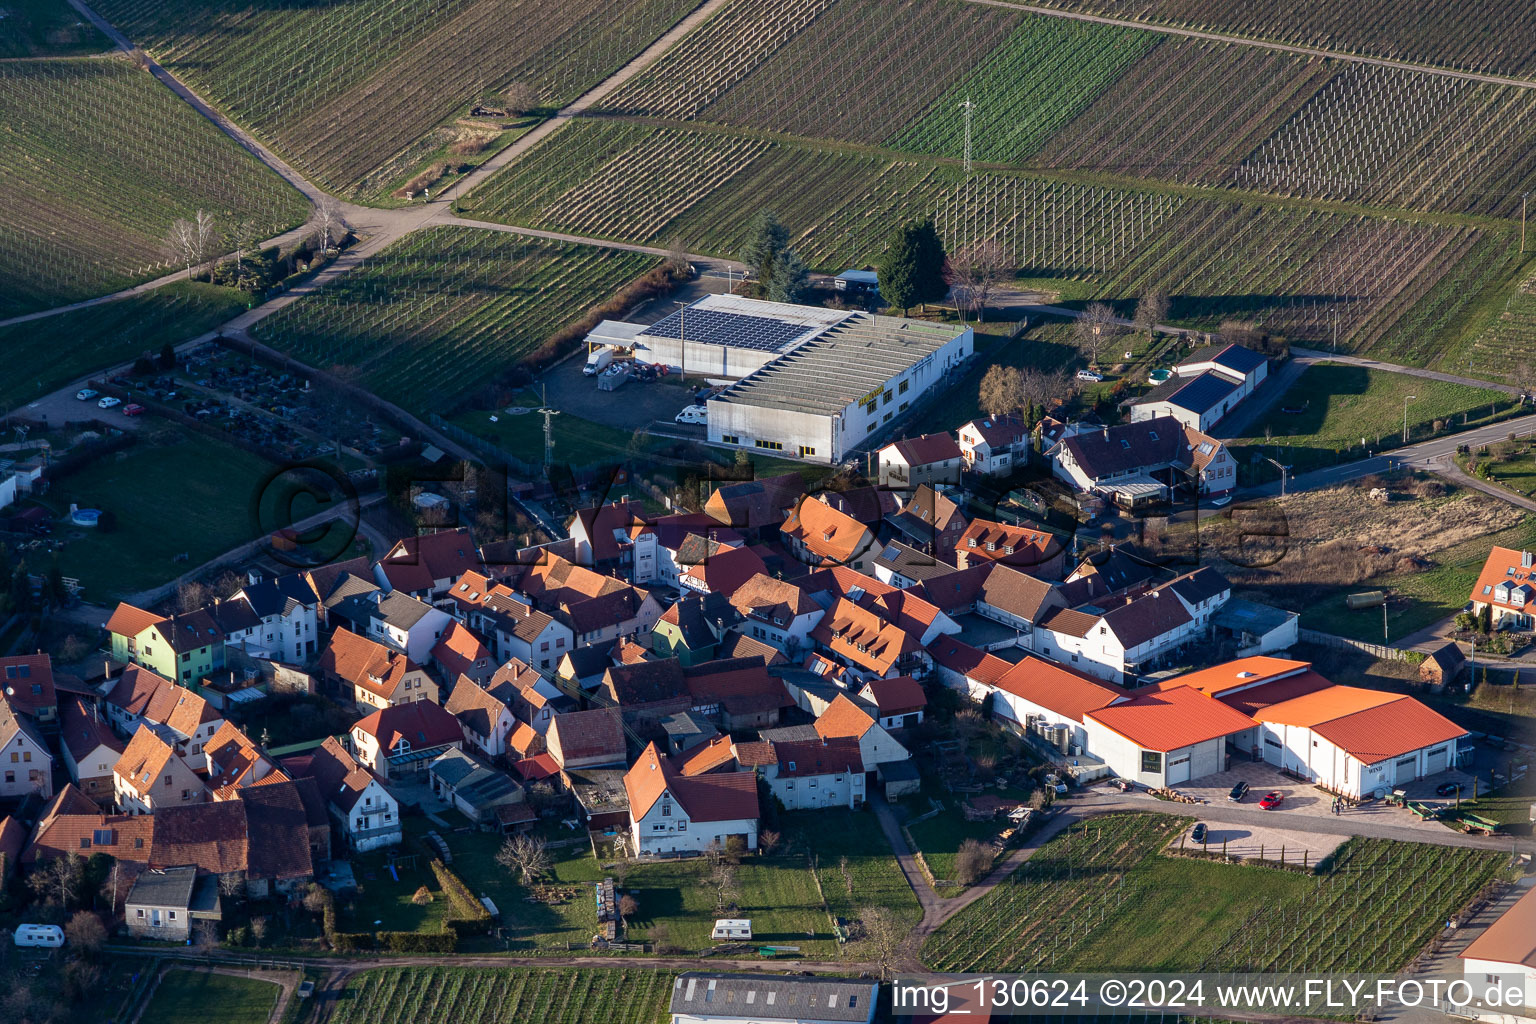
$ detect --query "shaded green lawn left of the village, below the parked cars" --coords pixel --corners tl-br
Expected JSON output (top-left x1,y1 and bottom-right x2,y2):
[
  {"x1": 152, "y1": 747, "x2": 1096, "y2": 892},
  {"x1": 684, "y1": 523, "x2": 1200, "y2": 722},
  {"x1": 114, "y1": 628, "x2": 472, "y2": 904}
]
[{"x1": 32, "y1": 431, "x2": 273, "y2": 603}]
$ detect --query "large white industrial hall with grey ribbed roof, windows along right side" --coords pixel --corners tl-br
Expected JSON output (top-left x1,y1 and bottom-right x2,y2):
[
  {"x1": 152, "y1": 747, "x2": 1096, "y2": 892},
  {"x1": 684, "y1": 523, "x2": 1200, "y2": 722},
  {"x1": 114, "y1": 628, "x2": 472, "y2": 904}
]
[{"x1": 708, "y1": 299, "x2": 975, "y2": 464}]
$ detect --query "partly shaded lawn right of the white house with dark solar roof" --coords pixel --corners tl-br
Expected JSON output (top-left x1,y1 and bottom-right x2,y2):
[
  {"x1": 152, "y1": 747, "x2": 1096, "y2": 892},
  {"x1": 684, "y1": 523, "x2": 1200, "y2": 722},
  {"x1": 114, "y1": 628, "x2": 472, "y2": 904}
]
[{"x1": 1232, "y1": 362, "x2": 1511, "y2": 473}]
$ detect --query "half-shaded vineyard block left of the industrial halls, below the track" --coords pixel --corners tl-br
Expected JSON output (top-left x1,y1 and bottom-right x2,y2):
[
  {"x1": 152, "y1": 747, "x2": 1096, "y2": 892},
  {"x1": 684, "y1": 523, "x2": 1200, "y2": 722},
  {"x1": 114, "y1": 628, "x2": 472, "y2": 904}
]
[{"x1": 255, "y1": 227, "x2": 656, "y2": 413}]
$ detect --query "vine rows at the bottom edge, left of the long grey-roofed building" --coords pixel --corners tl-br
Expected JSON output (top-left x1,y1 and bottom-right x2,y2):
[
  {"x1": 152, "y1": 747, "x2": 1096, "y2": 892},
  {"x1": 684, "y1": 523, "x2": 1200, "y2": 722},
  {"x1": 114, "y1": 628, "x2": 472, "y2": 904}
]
[{"x1": 329, "y1": 967, "x2": 673, "y2": 1024}]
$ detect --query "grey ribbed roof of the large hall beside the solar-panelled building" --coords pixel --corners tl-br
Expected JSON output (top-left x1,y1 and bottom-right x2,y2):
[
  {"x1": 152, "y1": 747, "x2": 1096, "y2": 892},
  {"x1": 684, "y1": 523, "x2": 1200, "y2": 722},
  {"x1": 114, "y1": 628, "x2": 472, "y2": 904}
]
[{"x1": 710, "y1": 313, "x2": 968, "y2": 416}]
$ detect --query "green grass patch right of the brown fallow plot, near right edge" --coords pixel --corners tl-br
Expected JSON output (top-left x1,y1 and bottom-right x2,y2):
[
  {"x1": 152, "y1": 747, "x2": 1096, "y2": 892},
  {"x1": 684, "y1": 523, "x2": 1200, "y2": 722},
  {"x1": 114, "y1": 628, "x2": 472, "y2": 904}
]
[{"x1": 1301, "y1": 516, "x2": 1536, "y2": 643}]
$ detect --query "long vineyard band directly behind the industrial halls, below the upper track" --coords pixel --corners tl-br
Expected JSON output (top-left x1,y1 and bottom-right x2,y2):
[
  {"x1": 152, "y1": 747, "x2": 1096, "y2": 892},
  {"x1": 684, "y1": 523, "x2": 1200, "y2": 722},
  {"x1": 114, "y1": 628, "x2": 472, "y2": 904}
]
[{"x1": 468, "y1": 120, "x2": 1518, "y2": 353}]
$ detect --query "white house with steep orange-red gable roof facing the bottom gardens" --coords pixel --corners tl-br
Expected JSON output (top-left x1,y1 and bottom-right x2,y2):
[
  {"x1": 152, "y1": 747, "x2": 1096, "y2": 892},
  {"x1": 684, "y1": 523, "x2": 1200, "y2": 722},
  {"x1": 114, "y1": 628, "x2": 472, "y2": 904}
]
[{"x1": 624, "y1": 743, "x2": 759, "y2": 857}]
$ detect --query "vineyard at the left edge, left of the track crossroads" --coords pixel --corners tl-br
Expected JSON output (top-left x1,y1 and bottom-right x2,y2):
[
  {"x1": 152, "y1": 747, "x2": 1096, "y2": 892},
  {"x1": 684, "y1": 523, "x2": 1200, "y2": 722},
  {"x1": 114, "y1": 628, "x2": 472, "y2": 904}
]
[{"x1": 0, "y1": 57, "x2": 309, "y2": 318}]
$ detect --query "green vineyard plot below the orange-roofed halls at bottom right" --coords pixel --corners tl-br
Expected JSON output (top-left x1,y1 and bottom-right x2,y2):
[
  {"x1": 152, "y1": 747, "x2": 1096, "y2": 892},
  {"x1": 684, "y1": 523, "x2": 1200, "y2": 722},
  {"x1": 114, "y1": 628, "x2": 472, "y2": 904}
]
[{"x1": 923, "y1": 815, "x2": 1504, "y2": 972}]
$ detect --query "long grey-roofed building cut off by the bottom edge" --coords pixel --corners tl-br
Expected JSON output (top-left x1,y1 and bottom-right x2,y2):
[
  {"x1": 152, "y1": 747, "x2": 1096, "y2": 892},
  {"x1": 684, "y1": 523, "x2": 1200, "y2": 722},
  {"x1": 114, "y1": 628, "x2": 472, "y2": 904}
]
[{"x1": 667, "y1": 970, "x2": 879, "y2": 1021}]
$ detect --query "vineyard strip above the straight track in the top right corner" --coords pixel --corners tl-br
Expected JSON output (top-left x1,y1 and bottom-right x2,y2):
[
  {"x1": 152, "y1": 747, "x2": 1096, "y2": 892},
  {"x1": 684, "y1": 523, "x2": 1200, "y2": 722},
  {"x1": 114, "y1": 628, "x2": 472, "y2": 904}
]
[{"x1": 1037, "y1": 0, "x2": 1536, "y2": 78}]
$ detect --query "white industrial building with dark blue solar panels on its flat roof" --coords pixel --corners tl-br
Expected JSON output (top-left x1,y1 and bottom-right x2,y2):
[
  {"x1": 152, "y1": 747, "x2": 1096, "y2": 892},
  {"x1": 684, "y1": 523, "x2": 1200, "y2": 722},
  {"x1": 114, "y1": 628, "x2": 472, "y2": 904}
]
[{"x1": 623, "y1": 295, "x2": 848, "y2": 379}]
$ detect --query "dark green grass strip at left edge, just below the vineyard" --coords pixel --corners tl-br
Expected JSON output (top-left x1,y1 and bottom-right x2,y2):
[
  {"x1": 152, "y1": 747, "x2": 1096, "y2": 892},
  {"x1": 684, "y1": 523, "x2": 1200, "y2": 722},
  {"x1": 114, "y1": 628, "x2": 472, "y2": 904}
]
[{"x1": 0, "y1": 281, "x2": 247, "y2": 408}]
